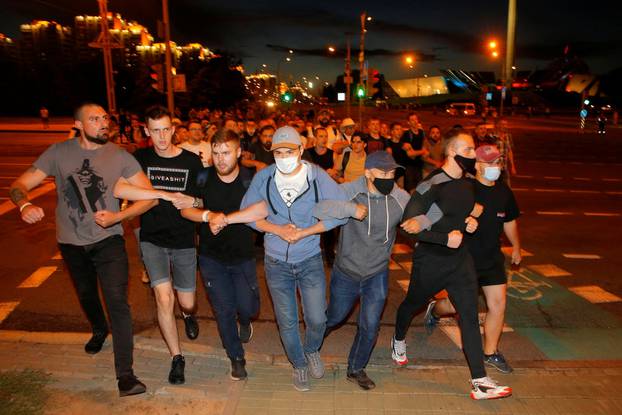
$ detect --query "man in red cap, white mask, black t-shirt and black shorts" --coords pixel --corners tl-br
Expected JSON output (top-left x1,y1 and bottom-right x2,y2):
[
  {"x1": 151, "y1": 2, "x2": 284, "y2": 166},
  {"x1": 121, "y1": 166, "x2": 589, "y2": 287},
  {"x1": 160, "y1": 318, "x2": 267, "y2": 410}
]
[{"x1": 425, "y1": 145, "x2": 521, "y2": 373}]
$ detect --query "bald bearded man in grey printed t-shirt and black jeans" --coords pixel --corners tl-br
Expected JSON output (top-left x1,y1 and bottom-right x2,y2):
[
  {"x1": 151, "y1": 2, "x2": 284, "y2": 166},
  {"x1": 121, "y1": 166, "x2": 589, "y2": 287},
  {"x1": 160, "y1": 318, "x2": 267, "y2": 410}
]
[{"x1": 10, "y1": 103, "x2": 179, "y2": 396}]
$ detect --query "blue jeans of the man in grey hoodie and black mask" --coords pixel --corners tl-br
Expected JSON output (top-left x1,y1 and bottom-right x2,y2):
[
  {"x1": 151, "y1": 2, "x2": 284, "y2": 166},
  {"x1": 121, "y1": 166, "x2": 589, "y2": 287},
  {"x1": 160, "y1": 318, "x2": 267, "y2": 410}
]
[{"x1": 326, "y1": 267, "x2": 389, "y2": 373}]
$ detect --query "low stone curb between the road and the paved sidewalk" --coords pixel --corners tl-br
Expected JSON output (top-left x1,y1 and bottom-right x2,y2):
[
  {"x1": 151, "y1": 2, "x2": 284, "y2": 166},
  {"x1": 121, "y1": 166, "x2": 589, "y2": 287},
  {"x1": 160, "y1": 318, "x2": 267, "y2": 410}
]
[{"x1": 0, "y1": 330, "x2": 622, "y2": 371}]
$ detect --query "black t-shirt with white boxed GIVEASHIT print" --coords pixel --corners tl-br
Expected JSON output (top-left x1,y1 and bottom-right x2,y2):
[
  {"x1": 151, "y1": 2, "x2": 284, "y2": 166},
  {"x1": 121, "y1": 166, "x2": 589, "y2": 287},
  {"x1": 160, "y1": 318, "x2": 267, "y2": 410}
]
[{"x1": 134, "y1": 148, "x2": 203, "y2": 249}]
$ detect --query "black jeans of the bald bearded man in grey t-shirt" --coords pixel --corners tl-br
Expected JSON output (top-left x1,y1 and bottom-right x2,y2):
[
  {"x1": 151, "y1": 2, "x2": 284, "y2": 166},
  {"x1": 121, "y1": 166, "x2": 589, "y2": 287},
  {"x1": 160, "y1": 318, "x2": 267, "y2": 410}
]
[{"x1": 58, "y1": 235, "x2": 134, "y2": 378}]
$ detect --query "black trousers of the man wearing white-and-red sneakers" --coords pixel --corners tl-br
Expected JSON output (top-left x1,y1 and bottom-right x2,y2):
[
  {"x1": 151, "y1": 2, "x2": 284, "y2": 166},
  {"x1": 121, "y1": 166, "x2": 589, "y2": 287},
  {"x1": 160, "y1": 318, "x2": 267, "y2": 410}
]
[{"x1": 395, "y1": 246, "x2": 486, "y2": 379}]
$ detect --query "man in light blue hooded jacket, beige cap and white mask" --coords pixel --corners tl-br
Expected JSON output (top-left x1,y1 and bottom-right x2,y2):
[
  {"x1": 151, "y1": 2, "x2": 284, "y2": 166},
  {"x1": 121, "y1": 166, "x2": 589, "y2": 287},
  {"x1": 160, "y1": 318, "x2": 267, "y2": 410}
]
[{"x1": 241, "y1": 127, "x2": 346, "y2": 391}]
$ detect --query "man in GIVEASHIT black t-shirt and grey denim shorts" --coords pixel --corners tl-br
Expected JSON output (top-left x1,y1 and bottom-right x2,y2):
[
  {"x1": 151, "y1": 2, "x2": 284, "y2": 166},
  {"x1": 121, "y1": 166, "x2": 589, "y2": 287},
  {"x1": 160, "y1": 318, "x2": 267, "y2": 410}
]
[{"x1": 134, "y1": 107, "x2": 203, "y2": 384}]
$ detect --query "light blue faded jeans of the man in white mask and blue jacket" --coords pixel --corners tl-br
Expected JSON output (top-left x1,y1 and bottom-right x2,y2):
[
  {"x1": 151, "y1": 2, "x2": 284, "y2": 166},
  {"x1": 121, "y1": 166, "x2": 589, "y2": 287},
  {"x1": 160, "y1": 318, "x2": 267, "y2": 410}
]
[{"x1": 264, "y1": 254, "x2": 326, "y2": 368}]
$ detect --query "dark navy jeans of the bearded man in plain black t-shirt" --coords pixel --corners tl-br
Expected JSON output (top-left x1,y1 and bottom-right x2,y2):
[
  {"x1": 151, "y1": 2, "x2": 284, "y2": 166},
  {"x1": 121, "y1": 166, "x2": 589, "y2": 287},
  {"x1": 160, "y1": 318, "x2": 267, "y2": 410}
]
[{"x1": 199, "y1": 255, "x2": 259, "y2": 359}]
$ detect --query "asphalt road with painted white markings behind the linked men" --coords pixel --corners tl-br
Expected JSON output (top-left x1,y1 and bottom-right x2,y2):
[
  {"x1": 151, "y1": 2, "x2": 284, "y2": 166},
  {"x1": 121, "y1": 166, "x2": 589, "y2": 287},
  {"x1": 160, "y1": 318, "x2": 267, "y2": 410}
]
[{"x1": 0, "y1": 112, "x2": 622, "y2": 360}]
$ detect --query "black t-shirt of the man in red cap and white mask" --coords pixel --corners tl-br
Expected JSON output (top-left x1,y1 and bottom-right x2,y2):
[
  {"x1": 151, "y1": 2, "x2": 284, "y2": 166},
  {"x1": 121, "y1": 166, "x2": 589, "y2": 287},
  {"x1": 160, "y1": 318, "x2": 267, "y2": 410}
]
[{"x1": 466, "y1": 180, "x2": 520, "y2": 269}]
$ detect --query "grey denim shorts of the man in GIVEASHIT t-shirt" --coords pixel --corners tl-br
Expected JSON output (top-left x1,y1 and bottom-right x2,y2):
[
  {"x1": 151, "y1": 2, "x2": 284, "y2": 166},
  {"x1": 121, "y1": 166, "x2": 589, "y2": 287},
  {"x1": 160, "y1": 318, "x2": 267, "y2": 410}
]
[{"x1": 140, "y1": 241, "x2": 197, "y2": 292}]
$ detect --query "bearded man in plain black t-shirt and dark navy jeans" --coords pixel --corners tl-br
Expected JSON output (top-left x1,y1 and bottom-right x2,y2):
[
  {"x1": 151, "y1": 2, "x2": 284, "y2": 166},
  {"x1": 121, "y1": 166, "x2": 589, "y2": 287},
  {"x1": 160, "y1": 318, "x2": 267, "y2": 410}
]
[{"x1": 182, "y1": 131, "x2": 267, "y2": 380}]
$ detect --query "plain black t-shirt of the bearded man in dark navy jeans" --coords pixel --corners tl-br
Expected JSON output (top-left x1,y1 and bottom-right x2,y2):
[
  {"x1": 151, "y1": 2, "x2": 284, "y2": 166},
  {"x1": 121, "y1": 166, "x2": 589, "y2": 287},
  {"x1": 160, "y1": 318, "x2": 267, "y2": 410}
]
[{"x1": 199, "y1": 167, "x2": 255, "y2": 264}]
